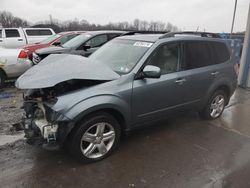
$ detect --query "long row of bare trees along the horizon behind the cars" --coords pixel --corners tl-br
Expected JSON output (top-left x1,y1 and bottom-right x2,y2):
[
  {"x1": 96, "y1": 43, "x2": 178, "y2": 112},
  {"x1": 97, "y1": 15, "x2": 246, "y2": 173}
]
[{"x1": 0, "y1": 11, "x2": 178, "y2": 32}]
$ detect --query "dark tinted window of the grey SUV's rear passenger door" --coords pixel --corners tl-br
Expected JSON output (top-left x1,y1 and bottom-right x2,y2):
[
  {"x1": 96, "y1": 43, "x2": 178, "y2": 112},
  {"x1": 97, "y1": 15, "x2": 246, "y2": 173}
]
[{"x1": 182, "y1": 41, "x2": 213, "y2": 70}]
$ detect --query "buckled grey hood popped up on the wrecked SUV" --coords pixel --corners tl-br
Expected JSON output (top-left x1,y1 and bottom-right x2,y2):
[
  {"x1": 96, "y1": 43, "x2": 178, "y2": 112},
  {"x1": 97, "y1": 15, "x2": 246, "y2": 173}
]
[{"x1": 16, "y1": 54, "x2": 120, "y2": 89}]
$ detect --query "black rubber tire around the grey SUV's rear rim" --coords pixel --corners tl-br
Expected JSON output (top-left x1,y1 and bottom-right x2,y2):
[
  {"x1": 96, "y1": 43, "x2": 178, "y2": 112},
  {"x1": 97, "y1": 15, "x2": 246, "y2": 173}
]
[{"x1": 199, "y1": 90, "x2": 228, "y2": 120}]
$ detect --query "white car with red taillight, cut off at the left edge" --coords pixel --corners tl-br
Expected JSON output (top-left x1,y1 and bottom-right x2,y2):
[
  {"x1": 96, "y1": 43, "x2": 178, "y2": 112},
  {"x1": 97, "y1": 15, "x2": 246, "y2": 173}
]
[{"x1": 0, "y1": 47, "x2": 33, "y2": 88}]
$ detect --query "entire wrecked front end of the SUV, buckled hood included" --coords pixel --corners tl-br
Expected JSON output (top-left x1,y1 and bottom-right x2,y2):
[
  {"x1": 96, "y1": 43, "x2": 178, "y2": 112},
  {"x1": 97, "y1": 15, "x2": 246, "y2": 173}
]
[{"x1": 16, "y1": 54, "x2": 120, "y2": 149}]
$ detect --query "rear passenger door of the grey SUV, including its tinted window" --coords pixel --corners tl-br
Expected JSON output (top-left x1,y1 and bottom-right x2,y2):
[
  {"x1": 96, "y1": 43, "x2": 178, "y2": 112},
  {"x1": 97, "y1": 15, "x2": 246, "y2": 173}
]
[{"x1": 178, "y1": 41, "x2": 217, "y2": 105}]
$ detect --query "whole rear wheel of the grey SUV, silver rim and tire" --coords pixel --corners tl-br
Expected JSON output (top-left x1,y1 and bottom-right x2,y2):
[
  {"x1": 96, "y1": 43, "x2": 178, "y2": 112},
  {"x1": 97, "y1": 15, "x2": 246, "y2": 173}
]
[{"x1": 200, "y1": 90, "x2": 227, "y2": 119}]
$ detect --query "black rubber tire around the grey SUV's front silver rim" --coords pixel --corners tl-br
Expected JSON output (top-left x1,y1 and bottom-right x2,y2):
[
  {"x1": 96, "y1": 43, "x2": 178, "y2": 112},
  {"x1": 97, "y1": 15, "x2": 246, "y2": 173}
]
[{"x1": 67, "y1": 113, "x2": 121, "y2": 163}]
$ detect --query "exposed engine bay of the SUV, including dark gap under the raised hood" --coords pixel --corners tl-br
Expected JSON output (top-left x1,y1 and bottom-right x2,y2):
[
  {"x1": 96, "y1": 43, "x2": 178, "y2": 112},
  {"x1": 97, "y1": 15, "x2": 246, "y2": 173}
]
[{"x1": 22, "y1": 80, "x2": 105, "y2": 149}]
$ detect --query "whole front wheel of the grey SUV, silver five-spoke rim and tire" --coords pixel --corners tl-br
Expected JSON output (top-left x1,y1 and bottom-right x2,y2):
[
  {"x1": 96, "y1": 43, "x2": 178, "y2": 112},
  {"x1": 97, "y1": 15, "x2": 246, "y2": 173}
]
[{"x1": 69, "y1": 113, "x2": 121, "y2": 163}]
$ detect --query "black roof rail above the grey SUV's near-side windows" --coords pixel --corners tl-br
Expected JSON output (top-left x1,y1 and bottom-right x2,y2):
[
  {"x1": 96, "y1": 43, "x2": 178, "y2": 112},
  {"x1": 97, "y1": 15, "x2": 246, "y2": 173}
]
[{"x1": 159, "y1": 31, "x2": 221, "y2": 39}]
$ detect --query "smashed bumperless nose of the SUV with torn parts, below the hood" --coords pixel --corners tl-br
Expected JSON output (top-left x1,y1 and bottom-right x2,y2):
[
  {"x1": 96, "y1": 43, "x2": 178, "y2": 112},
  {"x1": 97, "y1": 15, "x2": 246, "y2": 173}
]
[{"x1": 22, "y1": 89, "x2": 73, "y2": 150}]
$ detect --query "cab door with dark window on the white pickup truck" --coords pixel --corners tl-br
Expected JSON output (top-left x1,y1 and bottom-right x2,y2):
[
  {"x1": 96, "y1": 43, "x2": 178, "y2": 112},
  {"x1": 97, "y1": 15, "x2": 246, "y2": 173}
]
[{"x1": 4, "y1": 29, "x2": 26, "y2": 48}]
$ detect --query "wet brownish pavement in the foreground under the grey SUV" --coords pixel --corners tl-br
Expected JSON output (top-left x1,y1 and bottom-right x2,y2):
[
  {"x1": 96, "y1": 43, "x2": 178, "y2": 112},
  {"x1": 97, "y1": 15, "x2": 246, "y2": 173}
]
[{"x1": 0, "y1": 89, "x2": 250, "y2": 188}]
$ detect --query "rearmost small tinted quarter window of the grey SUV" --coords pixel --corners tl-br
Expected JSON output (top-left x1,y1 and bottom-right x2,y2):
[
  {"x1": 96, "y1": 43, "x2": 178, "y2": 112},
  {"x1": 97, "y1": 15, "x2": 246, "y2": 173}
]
[{"x1": 210, "y1": 42, "x2": 230, "y2": 64}]
